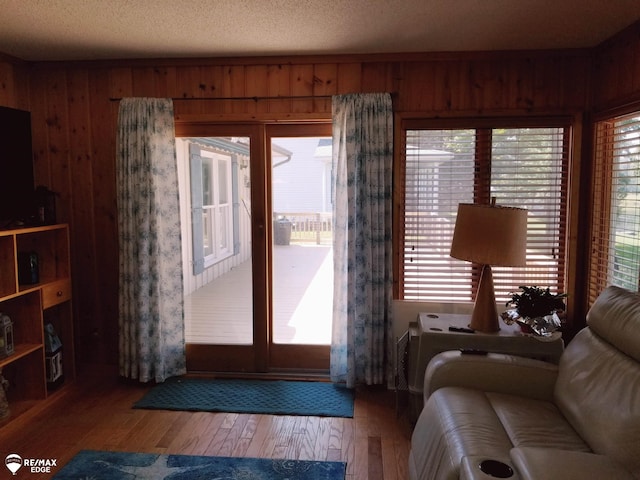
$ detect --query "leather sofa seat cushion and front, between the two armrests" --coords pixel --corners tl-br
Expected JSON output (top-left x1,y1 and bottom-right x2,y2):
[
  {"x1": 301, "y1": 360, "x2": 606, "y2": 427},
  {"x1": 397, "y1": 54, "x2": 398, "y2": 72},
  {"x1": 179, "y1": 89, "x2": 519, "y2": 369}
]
[{"x1": 411, "y1": 387, "x2": 590, "y2": 479}]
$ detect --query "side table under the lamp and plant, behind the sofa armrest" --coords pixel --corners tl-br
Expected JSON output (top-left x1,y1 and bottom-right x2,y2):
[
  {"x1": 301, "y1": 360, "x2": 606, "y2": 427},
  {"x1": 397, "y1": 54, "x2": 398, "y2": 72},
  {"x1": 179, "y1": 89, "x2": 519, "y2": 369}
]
[{"x1": 408, "y1": 313, "x2": 564, "y2": 422}]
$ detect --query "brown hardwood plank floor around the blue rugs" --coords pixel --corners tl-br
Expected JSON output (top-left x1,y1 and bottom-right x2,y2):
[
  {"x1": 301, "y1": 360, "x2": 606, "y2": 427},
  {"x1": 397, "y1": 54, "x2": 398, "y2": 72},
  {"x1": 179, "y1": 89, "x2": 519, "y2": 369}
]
[{"x1": 0, "y1": 369, "x2": 411, "y2": 480}]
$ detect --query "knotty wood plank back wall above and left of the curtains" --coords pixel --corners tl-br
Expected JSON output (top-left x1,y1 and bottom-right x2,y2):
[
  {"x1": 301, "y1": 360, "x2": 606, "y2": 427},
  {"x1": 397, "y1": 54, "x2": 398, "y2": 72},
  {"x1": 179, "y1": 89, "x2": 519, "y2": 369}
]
[{"x1": 0, "y1": 20, "x2": 640, "y2": 364}]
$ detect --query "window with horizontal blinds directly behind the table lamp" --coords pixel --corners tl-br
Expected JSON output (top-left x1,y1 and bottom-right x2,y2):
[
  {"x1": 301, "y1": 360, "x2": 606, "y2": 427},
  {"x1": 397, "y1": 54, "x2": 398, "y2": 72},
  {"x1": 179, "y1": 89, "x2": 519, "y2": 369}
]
[{"x1": 400, "y1": 127, "x2": 569, "y2": 303}]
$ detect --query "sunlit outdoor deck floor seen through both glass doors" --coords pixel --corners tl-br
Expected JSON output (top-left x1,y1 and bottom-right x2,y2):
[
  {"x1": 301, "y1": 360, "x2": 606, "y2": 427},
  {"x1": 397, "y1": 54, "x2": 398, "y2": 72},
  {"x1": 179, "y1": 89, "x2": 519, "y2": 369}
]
[{"x1": 185, "y1": 243, "x2": 333, "y2": 344}]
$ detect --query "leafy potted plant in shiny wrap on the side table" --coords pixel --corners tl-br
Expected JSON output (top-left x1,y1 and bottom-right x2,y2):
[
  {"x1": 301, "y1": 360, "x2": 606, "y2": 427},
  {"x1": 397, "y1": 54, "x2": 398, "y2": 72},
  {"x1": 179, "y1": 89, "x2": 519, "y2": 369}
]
[{"x1": 502, "y1": 286, "x2": 567, "y2": 336}]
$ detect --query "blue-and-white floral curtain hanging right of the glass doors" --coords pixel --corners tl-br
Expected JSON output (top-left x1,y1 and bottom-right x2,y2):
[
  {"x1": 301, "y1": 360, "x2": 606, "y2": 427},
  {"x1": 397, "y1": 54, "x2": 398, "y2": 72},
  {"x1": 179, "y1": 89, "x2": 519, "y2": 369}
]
[{"x1": 331, "y1": 94, "x2": 393, "y2": 388}]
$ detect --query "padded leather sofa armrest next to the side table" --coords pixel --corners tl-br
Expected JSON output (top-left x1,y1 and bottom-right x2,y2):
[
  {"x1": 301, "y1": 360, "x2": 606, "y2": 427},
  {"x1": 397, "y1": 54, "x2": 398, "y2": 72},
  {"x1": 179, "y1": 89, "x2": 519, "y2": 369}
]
[{"x1": 423, "y1": 350, "x2": 558, "y2": 403}]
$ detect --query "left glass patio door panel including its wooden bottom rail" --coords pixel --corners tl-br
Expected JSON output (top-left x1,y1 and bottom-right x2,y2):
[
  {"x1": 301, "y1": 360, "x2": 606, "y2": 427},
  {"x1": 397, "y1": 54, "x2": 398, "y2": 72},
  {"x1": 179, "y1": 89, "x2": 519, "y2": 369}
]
[{"x1": 176, "y1": 131, "x2": 255, "y2": 371}]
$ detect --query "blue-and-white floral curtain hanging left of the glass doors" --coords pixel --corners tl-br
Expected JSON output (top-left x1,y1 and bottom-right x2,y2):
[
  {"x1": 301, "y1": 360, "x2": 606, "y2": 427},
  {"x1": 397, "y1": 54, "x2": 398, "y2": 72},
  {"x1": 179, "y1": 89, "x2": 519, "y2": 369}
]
[{"x1": 116, "y1": 98, "x2": 186, "y2": 382}]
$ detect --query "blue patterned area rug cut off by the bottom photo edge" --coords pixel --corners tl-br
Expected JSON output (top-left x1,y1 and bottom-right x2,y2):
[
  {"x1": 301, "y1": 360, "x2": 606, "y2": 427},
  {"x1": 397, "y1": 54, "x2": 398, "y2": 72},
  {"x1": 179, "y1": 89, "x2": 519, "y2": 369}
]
[{"x1": 53, "y1": 450, "x2": 346, "y2": 480}]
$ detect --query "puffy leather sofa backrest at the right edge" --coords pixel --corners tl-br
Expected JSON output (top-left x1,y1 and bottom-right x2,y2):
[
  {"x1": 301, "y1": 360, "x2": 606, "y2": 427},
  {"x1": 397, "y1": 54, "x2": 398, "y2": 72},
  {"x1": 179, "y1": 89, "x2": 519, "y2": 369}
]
[{"x1": 554, "y1": 287, "x2": 640, "y2": 477}]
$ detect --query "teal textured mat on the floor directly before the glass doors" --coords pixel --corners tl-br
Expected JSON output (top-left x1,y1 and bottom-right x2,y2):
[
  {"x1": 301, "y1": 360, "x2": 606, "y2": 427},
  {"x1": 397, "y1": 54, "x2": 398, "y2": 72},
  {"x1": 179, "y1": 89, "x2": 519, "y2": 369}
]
[{"x1": 134, "y1": 377, "x2": 353, "y2": 417}]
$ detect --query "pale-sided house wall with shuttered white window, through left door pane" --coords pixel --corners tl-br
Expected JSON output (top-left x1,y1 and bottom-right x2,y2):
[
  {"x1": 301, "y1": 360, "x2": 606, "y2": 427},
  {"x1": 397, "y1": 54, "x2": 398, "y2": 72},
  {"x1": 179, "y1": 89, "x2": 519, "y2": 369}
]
[{"x1": 176, "y1": 137, "x2": 251, "y2": 295}]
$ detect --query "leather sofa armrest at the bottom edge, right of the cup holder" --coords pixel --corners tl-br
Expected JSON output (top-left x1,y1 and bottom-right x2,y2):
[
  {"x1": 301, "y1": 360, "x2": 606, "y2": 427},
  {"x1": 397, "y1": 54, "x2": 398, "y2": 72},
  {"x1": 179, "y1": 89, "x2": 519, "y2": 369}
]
[{"x1": 510, "y1": 447, "x2": 634, "y2": 480}]
